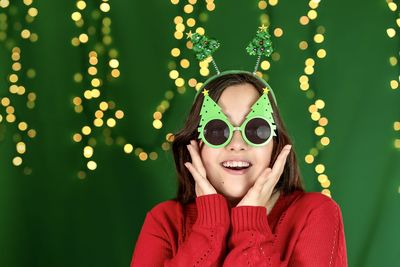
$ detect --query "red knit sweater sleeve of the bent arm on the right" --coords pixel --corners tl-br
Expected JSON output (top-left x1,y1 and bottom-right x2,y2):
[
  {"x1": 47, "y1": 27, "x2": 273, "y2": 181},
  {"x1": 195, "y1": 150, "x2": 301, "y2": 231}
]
[{"x1": 223, "y1": 200, "x2": 347, "y2": 267}]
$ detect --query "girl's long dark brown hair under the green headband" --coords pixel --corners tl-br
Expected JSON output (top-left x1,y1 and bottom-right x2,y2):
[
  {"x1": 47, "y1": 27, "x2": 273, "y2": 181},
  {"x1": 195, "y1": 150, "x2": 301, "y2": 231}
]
[{"x1": 172, "y1": 73, "x2": 304, "y2": 204}]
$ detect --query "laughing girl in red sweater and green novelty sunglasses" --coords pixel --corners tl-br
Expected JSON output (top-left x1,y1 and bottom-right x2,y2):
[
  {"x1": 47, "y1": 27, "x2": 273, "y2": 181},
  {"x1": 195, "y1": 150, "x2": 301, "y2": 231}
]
[{"x1": 131, "y1": 71, "x2": 347, "y2": 267}]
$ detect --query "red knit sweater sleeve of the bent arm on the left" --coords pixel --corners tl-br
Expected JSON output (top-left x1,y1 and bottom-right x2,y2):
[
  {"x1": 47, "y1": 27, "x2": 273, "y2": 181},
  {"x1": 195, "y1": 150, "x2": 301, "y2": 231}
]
[{"x1": 131, "y1": 194, "x2": 230, "y2": 267}]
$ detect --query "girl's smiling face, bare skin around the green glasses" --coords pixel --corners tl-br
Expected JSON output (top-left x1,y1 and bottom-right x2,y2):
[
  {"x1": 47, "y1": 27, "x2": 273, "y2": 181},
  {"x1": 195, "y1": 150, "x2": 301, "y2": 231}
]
[{"x1": 200, "y1": 83, "x2": 273, "y2": 203}]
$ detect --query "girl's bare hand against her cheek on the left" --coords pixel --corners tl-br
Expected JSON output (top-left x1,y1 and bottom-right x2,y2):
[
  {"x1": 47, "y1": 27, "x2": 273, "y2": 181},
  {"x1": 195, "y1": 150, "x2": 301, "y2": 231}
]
[{"x1": 185, "y1": 140, "x2": 217, "y2": 197}]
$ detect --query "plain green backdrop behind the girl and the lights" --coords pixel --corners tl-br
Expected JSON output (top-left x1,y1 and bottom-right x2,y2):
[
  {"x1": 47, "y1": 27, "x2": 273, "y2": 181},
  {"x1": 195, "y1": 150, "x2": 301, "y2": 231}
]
[{"x1": 0, "y1": 0, "x2": 400, "y2": 267}]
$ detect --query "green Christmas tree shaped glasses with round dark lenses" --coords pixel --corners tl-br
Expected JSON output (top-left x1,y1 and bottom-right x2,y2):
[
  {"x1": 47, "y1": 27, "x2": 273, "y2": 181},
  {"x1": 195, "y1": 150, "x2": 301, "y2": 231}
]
[{"x1": 198, "y1": 88, "x2": 276, "y2": 148}]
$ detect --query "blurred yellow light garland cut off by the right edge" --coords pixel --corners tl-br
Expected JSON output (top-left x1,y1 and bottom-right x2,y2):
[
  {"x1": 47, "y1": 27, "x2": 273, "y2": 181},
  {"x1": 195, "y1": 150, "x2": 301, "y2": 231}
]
[{"x1": 386, "y1": 0, "x2": 400, "y2": 154}]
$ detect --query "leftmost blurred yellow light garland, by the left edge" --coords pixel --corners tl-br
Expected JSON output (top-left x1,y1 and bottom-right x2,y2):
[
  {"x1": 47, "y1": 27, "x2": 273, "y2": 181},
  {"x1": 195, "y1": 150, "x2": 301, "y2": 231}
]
[{"x1": 0, "y1": 0, "x2": 38, "y2": 175}]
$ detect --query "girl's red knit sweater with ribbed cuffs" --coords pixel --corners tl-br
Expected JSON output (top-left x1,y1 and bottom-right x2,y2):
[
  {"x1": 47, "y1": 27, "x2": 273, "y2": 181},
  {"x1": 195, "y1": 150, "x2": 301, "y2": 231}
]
[{"x1": 131, "y1": 191, "x2": 347, "y2": 267}]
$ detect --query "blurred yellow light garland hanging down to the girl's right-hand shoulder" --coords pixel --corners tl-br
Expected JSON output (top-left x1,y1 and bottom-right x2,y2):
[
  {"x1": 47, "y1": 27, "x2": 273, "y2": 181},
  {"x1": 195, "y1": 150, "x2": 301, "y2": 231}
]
[{"x1": 299, "y1": 0, "x2": 331, "y2": 197}]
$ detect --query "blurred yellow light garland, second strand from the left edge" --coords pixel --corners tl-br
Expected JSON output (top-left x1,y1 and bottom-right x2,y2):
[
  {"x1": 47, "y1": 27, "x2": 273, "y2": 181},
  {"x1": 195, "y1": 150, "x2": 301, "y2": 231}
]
[{"x1": 71, "y1": 0, "x2": 129, "y2": 179}]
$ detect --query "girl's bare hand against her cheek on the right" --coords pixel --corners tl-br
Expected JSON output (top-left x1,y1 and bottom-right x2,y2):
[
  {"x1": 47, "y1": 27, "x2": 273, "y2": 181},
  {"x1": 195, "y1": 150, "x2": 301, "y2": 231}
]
[{"x1": 237, "y1": 145, "x2": 292, "y2": 207}]
